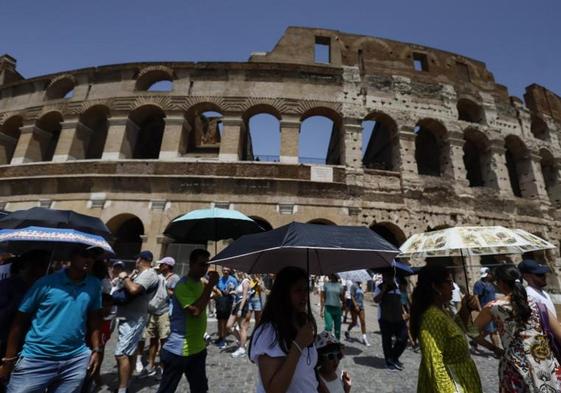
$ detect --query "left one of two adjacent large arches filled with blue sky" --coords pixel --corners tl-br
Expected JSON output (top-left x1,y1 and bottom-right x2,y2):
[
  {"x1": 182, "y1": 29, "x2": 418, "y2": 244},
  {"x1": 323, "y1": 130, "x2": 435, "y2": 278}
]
[{"x1": 242, "y1": 104, "x2": 282, "y2": 162}]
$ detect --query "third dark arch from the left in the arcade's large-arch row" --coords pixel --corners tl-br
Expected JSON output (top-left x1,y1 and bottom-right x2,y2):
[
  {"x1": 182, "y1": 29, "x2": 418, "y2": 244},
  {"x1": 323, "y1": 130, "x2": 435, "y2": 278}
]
[{"x1": 78, "y1": 105, "x2": 110, "y2": 159}]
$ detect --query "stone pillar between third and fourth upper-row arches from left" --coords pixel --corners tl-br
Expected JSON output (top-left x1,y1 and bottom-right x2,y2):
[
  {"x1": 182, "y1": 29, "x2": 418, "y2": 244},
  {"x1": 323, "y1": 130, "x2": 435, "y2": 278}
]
[{"x1": 101, "y1": 116, "x2": 138, "y2": 160}]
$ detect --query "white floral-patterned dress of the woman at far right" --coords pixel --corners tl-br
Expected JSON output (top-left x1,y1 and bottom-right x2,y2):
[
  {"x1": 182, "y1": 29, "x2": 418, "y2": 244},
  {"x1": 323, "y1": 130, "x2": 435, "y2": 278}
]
[{"x1": 488, "y1": 299, "x2": 561, "y2": 393}]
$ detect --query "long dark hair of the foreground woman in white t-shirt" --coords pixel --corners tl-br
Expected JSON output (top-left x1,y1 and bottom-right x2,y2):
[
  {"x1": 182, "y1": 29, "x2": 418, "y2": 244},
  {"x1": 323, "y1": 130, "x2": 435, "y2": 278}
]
[{"x1": 248, "y1": 266, "x2": 315, "y2": 357}]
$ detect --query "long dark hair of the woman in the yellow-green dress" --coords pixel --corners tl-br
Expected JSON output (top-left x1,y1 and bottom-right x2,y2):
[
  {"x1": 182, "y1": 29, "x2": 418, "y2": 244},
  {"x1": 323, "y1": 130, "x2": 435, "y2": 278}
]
[{"x1": 409, "y1": 265, "x2": 450, "y2": 339}]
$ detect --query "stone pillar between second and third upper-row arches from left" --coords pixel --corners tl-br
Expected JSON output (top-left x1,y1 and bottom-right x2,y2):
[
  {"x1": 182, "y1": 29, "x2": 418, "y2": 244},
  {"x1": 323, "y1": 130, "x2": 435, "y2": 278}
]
[{"x1": 53, "y1": 119, "x2": 94, "y2": 161}]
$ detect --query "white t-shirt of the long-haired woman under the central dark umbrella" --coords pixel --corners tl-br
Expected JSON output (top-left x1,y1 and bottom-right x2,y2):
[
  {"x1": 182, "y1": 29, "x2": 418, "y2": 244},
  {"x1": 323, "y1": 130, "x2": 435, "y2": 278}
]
[{"x1": 250, "y1": 324, "x2": 318, "y2": 393}]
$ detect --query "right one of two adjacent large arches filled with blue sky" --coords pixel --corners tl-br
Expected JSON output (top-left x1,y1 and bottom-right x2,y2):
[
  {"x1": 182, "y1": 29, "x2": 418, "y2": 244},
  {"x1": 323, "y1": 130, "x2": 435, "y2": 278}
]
[{"x1": 298, "y1": 107, "x2": 343, "y2": 165}]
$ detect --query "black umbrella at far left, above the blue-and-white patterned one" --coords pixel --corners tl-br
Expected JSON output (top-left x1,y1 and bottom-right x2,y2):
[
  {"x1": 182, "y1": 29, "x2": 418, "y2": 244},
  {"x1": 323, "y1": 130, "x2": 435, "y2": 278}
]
[{"x1": 0, "y1": 207, "x2": 111, "y2": 239}]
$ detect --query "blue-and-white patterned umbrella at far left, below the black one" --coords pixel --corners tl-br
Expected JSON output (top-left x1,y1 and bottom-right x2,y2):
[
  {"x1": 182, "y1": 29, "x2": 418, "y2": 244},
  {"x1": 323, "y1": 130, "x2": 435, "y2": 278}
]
[{"x1": 0, "y1": 226, "x2": 114, "y2": 254}]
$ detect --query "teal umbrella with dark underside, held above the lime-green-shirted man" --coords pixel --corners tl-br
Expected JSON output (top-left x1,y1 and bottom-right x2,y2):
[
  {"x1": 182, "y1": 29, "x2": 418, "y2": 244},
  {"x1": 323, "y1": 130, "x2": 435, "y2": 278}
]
[{"x1": 164, "y1": 207, "x2": 263, "y2": 243}]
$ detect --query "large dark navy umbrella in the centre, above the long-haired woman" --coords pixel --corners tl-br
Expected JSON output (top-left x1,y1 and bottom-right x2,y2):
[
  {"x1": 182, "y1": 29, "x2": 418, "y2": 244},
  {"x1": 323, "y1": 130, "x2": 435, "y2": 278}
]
[{"x1": 212, "y1": 222, "x2": 399, "y2": 274}]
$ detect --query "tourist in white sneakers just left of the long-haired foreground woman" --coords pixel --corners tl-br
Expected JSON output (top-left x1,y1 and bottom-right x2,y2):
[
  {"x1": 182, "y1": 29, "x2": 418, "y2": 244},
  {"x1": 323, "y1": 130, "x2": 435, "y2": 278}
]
[{"x1": 226, "y1": 273, "x2": 251, "y2": 358}]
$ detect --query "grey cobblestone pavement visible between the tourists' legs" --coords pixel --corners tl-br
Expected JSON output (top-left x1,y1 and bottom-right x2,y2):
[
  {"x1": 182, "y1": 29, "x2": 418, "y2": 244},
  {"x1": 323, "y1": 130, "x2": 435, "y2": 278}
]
[{"x1": 97, "y1": 299, "x2": 498, "y2": 393}]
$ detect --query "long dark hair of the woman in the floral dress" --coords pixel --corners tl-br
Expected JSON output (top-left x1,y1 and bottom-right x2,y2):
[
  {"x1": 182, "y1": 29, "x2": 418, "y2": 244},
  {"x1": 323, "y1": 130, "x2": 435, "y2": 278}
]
[{"x1": 494, "y1": 264, "x2": 532, "y2": 325}]
